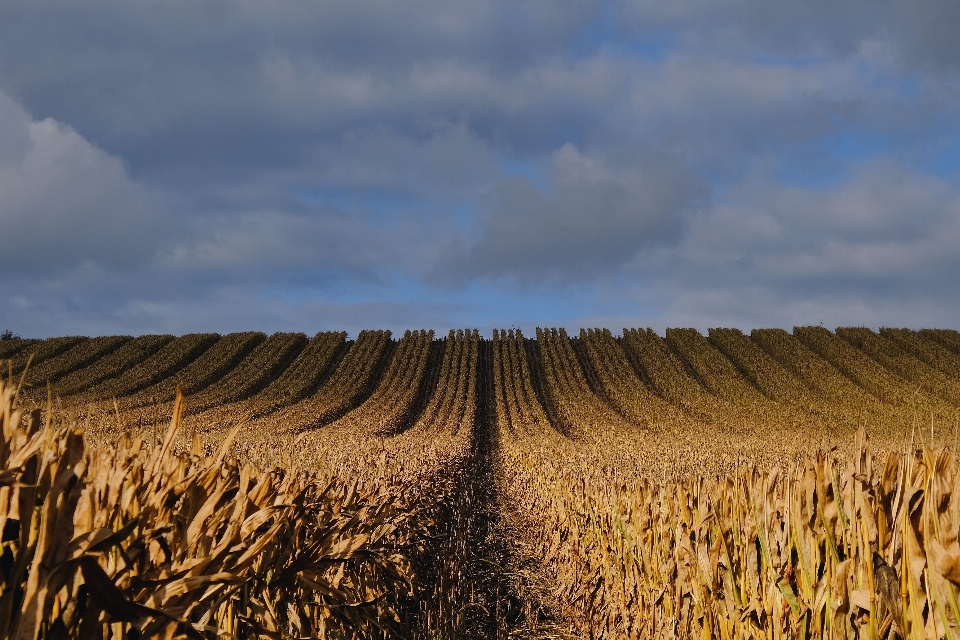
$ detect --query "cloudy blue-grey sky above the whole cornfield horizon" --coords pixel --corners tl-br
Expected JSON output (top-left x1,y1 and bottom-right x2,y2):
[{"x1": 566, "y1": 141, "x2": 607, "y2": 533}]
[{"x1": 0, "y1": 0, "x2": 960, "y2": 337}]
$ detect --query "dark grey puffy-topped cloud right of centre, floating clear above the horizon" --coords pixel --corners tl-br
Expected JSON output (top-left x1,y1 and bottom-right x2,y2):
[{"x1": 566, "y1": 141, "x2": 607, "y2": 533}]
[{"x1": 435, "y1": 143, "x2": 702, "y2": 281}]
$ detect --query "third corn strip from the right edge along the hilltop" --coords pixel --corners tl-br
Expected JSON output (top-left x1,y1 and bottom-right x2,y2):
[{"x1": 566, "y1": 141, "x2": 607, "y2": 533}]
[{"x1": 836, "y1": 327, "x2": 960, "y2": 407}]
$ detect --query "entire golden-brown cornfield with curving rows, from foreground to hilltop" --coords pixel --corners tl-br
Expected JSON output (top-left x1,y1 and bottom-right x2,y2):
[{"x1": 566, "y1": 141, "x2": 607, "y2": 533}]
[{"x1": 0, "y1": 327, "x2": 960, "y2": 640}]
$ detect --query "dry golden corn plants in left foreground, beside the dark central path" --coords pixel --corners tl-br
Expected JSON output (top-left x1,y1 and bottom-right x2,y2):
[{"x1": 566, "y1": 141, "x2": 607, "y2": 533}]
[{"x1": 0, "y1": 386, "x2": 425, "y2": 638}]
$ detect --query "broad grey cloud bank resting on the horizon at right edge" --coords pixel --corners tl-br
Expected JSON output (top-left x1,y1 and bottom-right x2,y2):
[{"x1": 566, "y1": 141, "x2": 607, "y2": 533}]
[{"x1": 612, "y1": 159, "x2": 960, "y2": 328}]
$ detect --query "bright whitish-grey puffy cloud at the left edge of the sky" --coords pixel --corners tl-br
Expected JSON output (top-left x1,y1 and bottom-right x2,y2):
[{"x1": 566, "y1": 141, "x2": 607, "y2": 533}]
[{"x1": 0, "y1": 92, "x2": 155, "y2": 274}]
